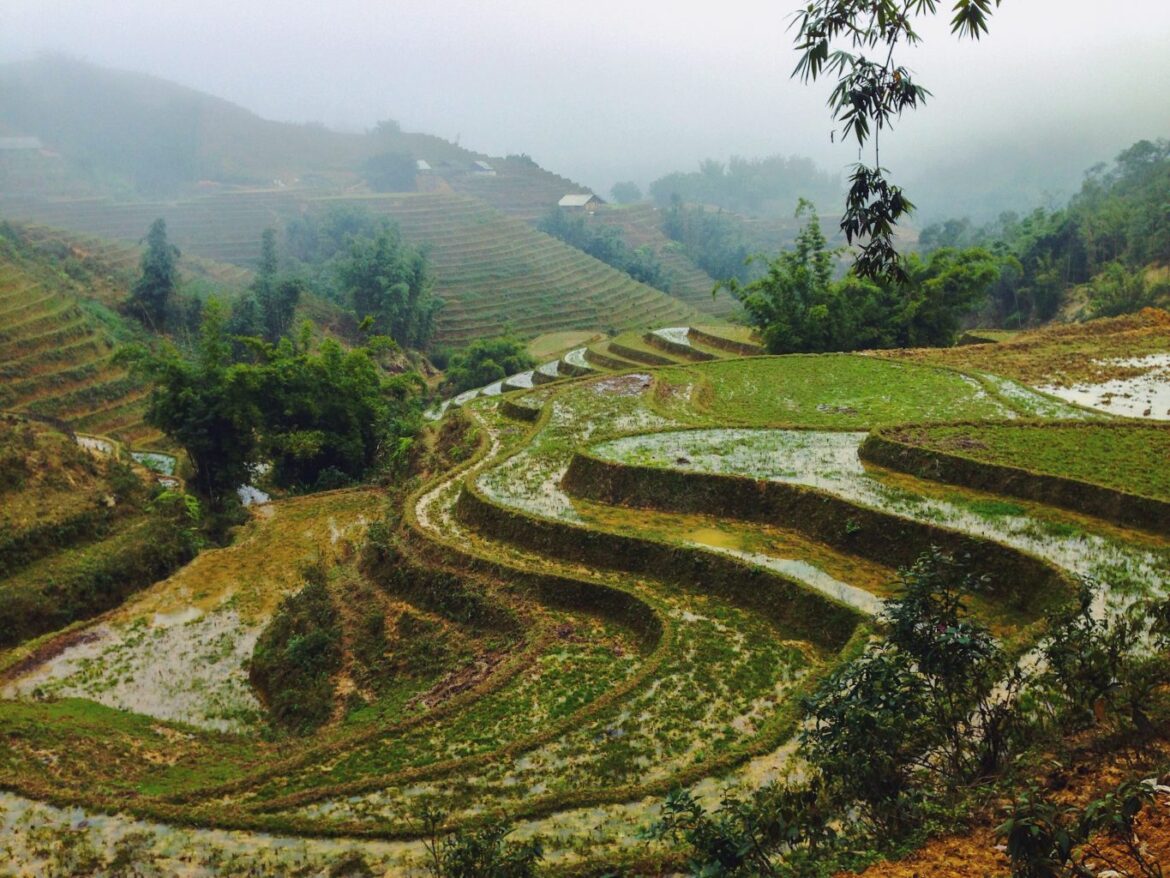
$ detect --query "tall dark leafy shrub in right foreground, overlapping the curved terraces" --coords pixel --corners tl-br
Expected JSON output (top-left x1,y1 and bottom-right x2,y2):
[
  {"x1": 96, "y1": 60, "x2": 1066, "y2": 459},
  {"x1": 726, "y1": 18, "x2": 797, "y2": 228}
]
[{"x1": 800, "y1": 550, "x2": 1021, "y2": 835}]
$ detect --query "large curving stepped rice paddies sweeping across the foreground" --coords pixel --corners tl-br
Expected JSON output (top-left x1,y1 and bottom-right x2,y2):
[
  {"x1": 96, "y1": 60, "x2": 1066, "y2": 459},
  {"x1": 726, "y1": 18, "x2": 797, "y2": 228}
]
[{"x1": 0, "y1": 316, "x2": 1170, "y2": 874}]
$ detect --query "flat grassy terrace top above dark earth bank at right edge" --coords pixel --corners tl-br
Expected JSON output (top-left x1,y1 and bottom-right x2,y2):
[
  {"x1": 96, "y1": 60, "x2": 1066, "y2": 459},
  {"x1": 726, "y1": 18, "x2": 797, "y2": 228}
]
[{"x1": 899, "y1": 423, "x2": 1170, "y2": 500}]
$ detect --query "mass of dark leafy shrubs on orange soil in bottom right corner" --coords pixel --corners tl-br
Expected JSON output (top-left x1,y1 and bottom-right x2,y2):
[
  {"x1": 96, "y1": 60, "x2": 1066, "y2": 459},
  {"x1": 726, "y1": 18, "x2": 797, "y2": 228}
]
[{"x1": 653, "y1": 551, "x2": 1170, "y2": 877}]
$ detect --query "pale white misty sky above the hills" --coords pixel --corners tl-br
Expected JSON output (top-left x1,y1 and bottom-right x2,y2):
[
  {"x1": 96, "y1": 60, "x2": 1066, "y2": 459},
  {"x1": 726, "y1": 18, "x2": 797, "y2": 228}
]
[{"x1": 0, "y1": 0, "x2": 1170, "y2": 215}]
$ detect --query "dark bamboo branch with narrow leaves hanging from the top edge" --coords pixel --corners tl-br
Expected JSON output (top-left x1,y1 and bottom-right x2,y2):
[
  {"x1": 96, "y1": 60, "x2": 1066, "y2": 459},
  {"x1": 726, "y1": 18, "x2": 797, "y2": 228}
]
[{"x1": 792, "y1": 0, "x2": 1000, "y2": 281}]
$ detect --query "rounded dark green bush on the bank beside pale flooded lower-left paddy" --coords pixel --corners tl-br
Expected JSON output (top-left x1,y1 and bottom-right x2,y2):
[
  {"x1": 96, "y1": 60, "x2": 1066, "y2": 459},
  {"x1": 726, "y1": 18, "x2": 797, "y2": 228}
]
[{"x1": 248, "y1": 569, "x2": 342, "y2": 734}]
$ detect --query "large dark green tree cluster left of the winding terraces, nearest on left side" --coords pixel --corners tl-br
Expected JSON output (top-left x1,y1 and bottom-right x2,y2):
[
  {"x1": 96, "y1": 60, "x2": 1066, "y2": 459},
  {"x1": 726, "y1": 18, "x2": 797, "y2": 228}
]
[{"x1": 119, "y1": 300, "x2": 425, "y2": 510}]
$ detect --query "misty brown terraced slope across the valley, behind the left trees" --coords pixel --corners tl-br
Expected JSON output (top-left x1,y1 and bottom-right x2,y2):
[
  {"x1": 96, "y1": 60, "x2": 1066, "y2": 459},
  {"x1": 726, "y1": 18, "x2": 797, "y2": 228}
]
[{"x1": 6, "y1": 191, "x2": 709, "y2": 344}]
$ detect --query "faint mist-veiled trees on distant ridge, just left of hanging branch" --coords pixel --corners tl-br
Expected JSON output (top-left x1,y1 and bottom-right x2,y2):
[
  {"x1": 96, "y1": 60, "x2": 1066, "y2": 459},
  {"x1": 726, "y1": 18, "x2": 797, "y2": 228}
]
[{"x1": 651, "y1": 156, "x2": 841, "y2": 215}]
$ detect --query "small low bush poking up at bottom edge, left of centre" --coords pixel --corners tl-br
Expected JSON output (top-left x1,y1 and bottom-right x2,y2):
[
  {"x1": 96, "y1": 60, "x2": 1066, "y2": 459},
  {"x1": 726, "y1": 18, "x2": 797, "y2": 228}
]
[{"x1": 422, "y1": 808, "x2": 544, "y2": 878}]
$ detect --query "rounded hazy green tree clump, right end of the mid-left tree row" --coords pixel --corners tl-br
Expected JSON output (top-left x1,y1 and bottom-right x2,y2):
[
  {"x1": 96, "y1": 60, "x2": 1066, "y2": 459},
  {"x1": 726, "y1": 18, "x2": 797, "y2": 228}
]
[{"x1": 337, "y1": 227, "x2": 442, "y2": 349}]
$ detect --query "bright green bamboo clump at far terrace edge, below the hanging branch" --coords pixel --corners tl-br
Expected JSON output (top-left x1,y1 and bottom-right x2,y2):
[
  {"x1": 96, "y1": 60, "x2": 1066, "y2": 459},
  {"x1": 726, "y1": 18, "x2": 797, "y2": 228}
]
[{"x1": 724, "y1": 203, "x2": 999, "y2": 354}]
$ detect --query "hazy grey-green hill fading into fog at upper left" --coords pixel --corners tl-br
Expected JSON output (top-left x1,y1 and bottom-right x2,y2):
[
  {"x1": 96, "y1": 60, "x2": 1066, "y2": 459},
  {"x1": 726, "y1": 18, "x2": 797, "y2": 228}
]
[{"x1": 0, "y1": 56, "x2": 483, "y2": 197}]
